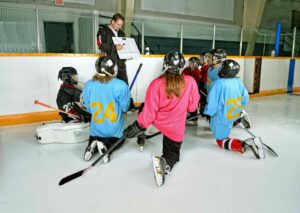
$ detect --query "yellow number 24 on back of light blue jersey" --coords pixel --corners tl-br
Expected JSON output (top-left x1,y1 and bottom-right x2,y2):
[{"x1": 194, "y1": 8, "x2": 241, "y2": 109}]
[{"x1": 90, "y1": 102, "x2": 117, "y2": 124}]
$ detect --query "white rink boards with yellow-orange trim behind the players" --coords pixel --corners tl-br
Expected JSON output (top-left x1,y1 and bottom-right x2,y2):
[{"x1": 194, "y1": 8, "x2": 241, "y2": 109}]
[{"x1": 0, "y1": 53, "x2": 300, "y2": 126}]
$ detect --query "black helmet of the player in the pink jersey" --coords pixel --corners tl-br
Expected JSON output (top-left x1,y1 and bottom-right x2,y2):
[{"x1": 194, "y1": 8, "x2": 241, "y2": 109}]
[{"x1": 163, "y1": 51, "x2": 185, "y2": 74}]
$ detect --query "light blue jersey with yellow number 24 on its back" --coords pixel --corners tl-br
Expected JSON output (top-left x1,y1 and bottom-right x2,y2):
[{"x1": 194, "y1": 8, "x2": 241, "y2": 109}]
[{"x1": 83, "y1": 78, "x2": 130, "y2": 138}]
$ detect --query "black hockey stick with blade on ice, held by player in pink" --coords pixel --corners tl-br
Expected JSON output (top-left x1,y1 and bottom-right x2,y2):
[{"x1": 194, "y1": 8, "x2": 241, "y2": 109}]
[{"x1": 58, "y1": 135, "x2": 126, "y2": 186}]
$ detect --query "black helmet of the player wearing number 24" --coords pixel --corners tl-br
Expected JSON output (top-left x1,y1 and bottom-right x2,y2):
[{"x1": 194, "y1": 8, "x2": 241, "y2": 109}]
[{"x1": 95, "y1": 56, "x2": 118, "y2": 77}]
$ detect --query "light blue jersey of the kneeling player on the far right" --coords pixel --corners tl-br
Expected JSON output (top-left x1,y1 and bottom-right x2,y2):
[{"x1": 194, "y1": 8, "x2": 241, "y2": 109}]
[{"x1": 204, "y1": 78, "x2": 249, "y2": 140}]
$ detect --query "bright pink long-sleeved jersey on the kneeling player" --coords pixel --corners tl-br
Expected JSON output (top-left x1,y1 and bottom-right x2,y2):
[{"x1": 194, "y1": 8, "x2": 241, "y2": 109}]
[{"x1": 138, "y1": 76, "x2": 200, "y2": 142}]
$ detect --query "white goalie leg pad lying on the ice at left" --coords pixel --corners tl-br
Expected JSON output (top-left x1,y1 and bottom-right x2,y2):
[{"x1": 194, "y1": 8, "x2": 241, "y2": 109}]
[{"x1": 36, "y1": 123, "x2": 90, "y2": 144}]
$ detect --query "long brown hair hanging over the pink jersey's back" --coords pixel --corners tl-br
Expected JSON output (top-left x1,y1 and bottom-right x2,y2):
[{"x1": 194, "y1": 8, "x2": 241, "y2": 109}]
[{"x1": 160, "y1": 71, "x2": 185, "y2": 98}]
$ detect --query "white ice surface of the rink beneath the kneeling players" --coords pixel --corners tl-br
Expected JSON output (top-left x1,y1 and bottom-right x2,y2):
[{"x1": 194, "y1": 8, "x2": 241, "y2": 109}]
[{"x1": 0, "y1": 95, "x2": 300, "y2": 213}]
